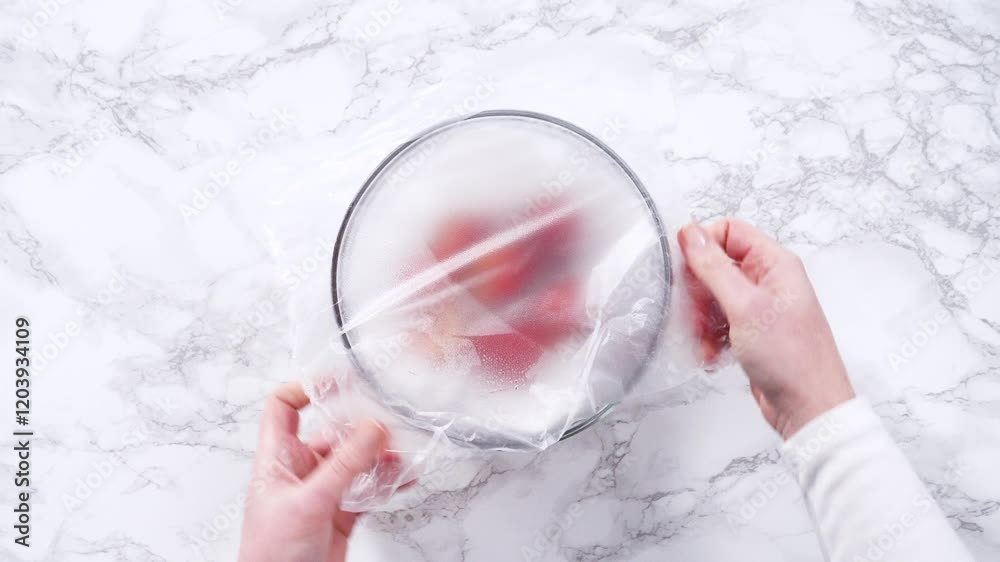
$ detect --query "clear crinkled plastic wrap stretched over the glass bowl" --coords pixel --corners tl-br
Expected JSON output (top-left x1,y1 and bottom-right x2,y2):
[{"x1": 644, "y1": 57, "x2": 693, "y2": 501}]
[{"x1": 292, "y1": 112, "x2": 716, "y2": 511}]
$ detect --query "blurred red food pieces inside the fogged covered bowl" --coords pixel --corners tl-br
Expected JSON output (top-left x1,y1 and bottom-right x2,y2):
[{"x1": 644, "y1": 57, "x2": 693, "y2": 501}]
[{"x1": 412, "y1": 201, "x2": 586, "y2": 387}]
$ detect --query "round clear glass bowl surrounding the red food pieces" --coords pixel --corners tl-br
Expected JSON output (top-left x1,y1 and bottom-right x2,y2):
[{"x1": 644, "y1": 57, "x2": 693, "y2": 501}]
[{"x1": 331, "y1": 110, "x2": 672, "y2": 450}]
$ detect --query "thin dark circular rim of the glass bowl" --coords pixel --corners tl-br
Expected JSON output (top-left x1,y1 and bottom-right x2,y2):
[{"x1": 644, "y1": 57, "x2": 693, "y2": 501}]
[{"x1": 330, "y1": 109, "x2": 673, "y2": 451}]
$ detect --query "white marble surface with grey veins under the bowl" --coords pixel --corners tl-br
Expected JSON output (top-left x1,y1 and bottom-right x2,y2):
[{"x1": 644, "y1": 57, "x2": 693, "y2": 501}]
[{"x1": 0, "y1": 0, "x2": 1000, "y2": 561}]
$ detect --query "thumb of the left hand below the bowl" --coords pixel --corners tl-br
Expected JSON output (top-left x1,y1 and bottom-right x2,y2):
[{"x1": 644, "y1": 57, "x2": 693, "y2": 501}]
[{"x1": 303, "y1": 421, "x2": 389, "y2": 514}]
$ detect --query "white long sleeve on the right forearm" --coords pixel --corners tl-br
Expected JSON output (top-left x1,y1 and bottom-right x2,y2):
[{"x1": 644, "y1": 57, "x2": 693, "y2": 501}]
[{"x1": 783, "y1": 398, "x2": 972, "y2": 562}]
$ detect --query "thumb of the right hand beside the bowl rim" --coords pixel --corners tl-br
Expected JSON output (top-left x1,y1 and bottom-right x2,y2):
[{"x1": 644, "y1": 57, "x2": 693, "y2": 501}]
[{"x1": 677, "y1": 224, "x2": 756, "y2": 318}]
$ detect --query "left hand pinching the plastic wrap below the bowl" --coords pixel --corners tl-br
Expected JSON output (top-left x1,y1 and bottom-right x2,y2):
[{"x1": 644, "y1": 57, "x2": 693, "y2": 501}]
[{"x1": 239, "y1": 383, "x2": 388, "y2": 562}]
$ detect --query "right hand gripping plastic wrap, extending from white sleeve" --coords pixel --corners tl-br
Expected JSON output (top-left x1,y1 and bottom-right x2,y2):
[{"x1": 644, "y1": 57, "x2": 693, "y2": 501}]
[{"x1": 677, "y1": 218, "x2": 854, "y2": 439}]
